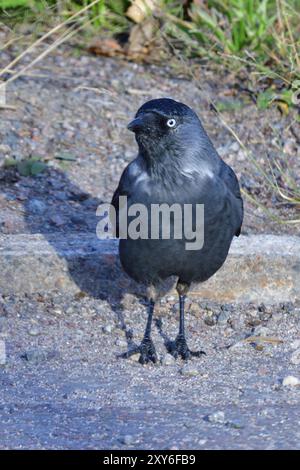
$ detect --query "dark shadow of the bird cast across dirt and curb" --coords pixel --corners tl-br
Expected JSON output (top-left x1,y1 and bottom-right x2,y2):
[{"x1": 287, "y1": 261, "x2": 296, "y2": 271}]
[{"x1": 0, "y1": 164, "x2": 148, "y2": 347}]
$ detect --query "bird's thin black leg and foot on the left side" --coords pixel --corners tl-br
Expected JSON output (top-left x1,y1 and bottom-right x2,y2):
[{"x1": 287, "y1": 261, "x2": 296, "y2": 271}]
[{"x1": 120, "y1": 299, "x2": 157, "y2": 364}]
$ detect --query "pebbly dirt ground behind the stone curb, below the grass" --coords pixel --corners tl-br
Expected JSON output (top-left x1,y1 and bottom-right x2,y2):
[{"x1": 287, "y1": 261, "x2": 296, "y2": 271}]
[{"x1": 0, "y1": 45, "x2": 300, "y2": 234}]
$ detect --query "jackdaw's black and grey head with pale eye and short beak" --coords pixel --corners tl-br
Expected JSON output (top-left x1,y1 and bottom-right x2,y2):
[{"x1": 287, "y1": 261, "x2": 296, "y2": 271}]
[{"x1": 128, "y1": 98, "x2": 204, "y2": 162}]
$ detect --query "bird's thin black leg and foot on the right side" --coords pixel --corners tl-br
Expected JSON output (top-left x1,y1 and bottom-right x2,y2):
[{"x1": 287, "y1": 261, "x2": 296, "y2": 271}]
[{"x1": 168, "y1": 281, "x2": 205, "y2": 359}]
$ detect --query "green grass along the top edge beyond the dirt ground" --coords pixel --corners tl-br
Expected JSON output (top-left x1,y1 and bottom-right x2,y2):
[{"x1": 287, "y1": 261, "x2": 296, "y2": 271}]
[{"x1": 0, "y1": 0, "x2": 300, "y2": 85}]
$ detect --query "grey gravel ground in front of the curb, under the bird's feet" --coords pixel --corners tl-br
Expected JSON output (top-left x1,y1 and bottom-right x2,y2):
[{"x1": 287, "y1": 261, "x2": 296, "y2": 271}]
[{"x1": 0, "y1": 293, "x2": 300, "y2": 449}]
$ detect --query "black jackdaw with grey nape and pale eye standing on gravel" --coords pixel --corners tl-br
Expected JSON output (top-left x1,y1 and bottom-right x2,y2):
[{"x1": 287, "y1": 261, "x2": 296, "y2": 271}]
[{"x1": 112, "y1": 98, "x2": 243, "y2": 364}]
